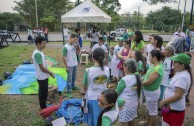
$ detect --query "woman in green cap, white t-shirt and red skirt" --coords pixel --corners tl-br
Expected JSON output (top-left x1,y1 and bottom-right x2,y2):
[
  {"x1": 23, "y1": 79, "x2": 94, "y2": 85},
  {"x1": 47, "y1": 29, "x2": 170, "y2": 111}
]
[{"x1": 160, "y1": 53, "x2": 192, "y2": 126}]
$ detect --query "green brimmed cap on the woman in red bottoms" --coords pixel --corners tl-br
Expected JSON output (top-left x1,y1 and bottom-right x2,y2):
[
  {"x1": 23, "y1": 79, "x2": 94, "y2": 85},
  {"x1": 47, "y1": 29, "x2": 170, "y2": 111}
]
[{"x1": 170, "y1": 53, "x2": 191, "y2": 64}]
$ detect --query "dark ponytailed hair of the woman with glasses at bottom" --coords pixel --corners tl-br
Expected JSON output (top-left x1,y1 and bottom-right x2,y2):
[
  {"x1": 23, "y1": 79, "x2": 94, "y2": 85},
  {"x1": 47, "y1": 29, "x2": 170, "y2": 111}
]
[{"x1": 97, "y1": 89, "x2": 117, "y2": 126}]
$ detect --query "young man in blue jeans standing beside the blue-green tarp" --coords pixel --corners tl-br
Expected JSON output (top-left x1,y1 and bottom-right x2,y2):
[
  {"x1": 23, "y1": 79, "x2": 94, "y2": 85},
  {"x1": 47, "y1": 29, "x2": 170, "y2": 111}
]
[{"x1": 63, "y1": 34, "x2": 79, "y2": 98}]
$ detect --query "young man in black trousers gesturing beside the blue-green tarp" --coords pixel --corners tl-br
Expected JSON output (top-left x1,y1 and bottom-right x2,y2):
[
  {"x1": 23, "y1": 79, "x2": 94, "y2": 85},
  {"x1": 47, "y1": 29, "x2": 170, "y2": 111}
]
[{"x1": 32, "y1": 36, "x2": 54, "y2": 109}]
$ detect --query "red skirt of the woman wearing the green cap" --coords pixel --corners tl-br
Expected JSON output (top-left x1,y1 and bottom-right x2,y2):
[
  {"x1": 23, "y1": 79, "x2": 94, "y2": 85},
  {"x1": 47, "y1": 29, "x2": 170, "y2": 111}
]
[{"x1": 162, "y1": 111, "x2": 185, "y2": 126}]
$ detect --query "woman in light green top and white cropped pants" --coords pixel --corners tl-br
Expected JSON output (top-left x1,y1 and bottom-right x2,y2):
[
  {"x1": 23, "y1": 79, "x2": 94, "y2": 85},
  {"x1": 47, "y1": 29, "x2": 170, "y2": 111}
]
[{"x1": 141, "y1": 50, "x2": 164, "y2": 126}]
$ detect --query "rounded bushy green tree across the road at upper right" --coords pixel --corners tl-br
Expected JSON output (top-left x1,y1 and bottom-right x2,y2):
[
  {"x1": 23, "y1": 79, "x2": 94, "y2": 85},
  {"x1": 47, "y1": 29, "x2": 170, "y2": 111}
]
[{"x1": 146, "y1": 6, "x2": 182, "y2": 31}]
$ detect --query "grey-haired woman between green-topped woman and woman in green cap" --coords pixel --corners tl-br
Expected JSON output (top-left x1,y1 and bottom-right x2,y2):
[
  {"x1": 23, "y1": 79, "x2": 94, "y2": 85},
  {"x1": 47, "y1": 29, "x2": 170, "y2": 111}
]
[{"x1": 159, "y1": 45, "x2": 175, "y2": 100}]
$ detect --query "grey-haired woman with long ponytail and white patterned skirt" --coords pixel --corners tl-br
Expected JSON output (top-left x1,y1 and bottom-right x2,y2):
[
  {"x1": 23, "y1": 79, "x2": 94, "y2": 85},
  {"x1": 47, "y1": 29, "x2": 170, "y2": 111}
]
[{"x1": 116, "y1": 58, "x2": 141, "y2": 126}]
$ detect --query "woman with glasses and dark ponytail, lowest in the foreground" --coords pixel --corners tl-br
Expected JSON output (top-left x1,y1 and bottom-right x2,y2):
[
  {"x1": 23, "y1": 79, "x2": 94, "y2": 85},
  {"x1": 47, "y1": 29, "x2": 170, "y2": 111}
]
[{"x1": 97, "y1": 89, "x2": 125, "y2": 126}]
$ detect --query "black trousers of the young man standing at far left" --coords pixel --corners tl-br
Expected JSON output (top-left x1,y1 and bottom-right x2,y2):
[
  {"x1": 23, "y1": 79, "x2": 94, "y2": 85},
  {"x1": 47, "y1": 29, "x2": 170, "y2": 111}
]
[{"x1": 37, "y1": 78, "x2": 48, "y2": 109}]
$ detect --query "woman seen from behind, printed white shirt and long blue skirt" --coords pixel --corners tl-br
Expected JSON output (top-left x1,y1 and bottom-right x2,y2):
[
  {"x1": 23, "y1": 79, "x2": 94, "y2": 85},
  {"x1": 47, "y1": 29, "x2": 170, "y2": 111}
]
[{"x1": 83, "y1": 48, "x2": 109, "y2": 126}]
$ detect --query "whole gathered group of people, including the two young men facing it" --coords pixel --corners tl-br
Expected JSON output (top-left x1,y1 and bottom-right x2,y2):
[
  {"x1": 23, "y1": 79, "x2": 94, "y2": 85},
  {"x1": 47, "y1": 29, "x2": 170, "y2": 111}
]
[{"x1": 32, "y1": 26, "x2": 192, "y2": 126}]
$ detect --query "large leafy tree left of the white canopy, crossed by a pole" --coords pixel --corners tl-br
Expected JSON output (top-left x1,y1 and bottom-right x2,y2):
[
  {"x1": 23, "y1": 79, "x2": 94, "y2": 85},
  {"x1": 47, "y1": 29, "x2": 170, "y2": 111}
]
[{"x1": 13, "y1": 0, "x2": 74, "y2": 30}]
